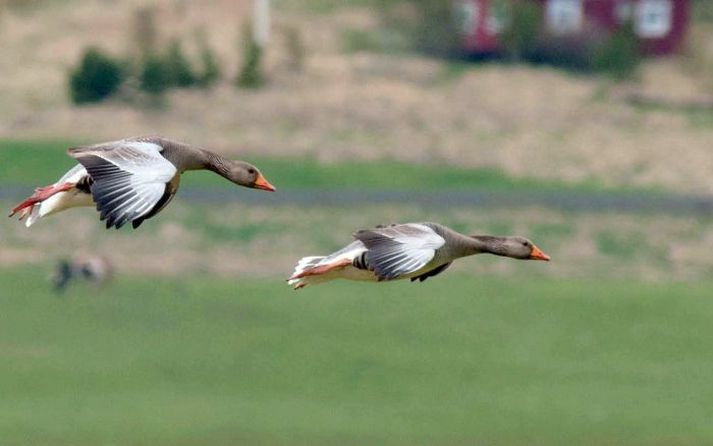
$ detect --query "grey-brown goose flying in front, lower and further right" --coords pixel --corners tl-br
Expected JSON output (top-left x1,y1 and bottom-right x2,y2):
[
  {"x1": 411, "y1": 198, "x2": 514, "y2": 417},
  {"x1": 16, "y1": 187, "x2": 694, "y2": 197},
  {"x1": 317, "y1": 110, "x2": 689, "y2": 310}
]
[{"x1": 287, "y1": 223, "x2": 550, "y2": 289}]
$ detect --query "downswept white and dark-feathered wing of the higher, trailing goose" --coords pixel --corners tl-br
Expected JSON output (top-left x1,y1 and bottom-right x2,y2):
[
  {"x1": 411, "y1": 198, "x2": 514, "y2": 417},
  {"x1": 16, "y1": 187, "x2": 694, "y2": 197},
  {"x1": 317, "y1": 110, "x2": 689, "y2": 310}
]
[{"x1": 68, "y1": 140, "x2": 177, "y2": 229}]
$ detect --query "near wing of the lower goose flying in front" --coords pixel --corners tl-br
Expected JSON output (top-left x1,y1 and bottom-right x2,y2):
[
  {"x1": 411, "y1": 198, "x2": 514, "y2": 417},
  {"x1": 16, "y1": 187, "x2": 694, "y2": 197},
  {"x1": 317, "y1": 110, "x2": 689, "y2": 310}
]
[{"x1": 354, "y1": 223, "x2": 446, "y2": 280}]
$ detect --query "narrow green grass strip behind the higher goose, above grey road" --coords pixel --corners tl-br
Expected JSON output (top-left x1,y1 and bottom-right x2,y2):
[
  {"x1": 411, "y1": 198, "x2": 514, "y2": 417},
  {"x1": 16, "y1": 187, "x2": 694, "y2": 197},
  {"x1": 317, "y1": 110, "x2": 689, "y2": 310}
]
[{"x1": 0, "y1": 140, "x2": 615, "y2": 192}]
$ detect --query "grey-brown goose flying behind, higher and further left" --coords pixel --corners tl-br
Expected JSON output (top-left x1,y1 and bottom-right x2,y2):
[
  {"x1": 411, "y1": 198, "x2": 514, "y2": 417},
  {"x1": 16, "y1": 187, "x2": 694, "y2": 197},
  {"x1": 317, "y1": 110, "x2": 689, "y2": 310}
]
[{"x1": 10, "y1": 136, "x2": 275, "y2": 229}]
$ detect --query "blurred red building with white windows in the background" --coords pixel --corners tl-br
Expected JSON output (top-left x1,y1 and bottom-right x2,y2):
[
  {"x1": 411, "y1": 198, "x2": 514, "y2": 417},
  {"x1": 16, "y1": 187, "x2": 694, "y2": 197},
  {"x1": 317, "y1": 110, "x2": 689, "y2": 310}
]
[{"x1": 458, "y1": 0, "x2": 688, "y2": 55}]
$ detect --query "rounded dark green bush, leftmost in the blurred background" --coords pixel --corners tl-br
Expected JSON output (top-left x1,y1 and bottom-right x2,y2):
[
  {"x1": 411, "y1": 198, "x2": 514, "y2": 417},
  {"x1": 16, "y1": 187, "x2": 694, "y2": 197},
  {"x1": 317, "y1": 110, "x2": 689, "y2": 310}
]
[{"x1": 69, "y1": 47, "x2": 124, "y2": 104}]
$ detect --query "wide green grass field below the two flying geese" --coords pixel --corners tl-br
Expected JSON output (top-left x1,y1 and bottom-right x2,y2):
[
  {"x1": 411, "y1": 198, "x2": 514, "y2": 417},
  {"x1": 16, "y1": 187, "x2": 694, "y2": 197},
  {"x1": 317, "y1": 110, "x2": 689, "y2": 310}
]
[{"x1": 0, "y1": 270, "x2": 713, "y2": 446}]
